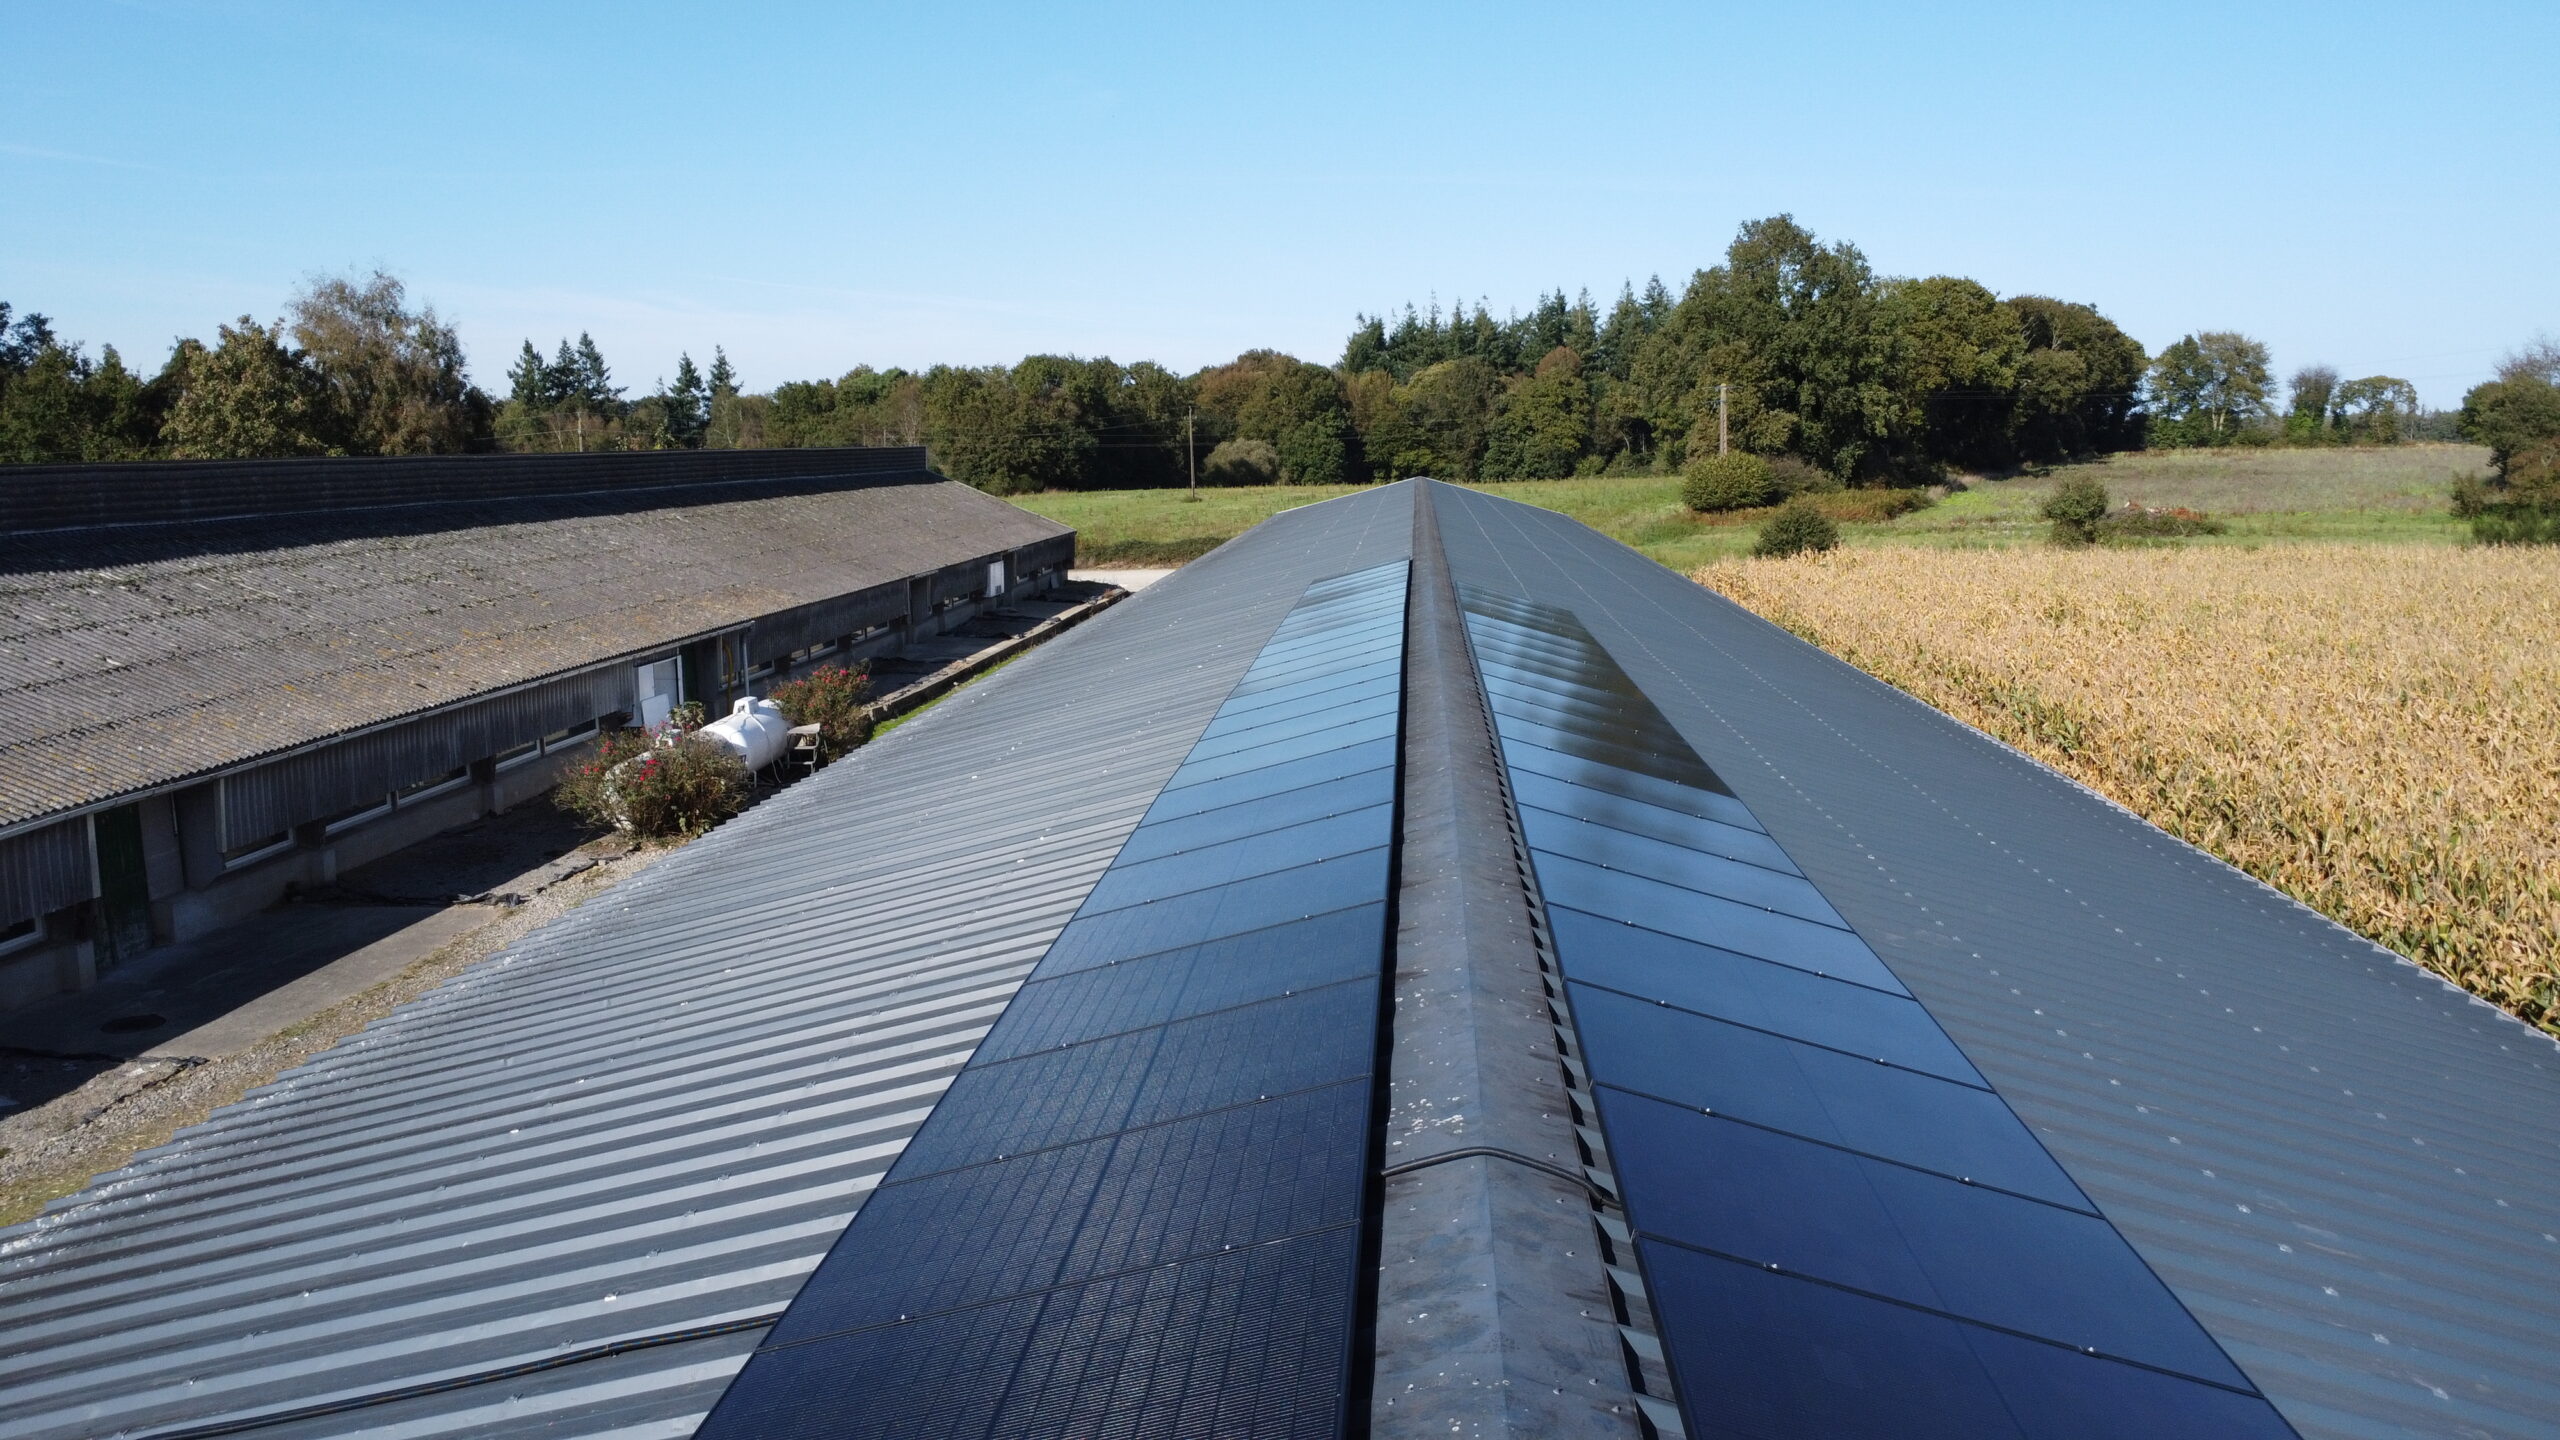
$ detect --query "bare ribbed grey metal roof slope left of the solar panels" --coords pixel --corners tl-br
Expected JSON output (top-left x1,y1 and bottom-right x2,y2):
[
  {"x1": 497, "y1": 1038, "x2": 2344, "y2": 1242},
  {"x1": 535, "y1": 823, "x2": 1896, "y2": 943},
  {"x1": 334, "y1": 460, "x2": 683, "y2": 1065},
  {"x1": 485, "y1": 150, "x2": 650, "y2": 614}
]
[{"x1": 0, "y1": 492, "x2": 1411, "y2": 1437}]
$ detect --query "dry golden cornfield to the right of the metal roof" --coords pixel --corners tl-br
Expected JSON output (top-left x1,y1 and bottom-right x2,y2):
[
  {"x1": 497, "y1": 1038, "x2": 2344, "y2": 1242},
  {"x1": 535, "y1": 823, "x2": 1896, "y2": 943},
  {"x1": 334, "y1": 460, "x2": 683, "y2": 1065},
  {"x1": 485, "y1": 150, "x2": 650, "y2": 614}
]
[{"x1": 1697, "y1": 546, "x2": 2560, "y2": 1035}]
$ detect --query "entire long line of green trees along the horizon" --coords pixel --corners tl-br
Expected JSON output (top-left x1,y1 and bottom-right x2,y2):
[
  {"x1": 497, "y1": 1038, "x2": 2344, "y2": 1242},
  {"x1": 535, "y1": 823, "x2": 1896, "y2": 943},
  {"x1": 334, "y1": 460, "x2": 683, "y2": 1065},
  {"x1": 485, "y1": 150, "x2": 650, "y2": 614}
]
[{"x1": 0, "y1": 215, "x2": 2498, "y2": 492}]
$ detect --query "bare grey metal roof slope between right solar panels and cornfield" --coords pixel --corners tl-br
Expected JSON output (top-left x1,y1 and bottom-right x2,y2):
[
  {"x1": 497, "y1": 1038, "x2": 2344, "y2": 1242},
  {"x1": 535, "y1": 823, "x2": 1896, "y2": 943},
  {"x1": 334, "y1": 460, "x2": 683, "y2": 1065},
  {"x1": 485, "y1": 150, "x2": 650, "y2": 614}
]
[{"x1": 1434, "y1": 489, "x2": 2560, "y2": 1440}]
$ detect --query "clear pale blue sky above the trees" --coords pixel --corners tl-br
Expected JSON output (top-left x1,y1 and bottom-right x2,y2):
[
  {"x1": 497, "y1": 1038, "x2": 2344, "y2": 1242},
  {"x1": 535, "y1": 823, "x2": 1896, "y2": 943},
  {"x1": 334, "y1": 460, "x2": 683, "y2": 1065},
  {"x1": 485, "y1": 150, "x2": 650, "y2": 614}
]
[{"x1": 0, "y1": 0, "x2": 2560, "y2": 405}]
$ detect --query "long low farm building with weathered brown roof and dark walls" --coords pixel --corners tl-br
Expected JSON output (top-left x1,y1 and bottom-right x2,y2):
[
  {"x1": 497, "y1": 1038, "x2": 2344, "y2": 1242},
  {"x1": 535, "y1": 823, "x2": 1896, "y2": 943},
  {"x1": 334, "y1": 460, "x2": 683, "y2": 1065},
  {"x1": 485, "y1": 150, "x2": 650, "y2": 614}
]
[{"x1": 0, "y1": 448, "x2": 1075, "y2": 1007}]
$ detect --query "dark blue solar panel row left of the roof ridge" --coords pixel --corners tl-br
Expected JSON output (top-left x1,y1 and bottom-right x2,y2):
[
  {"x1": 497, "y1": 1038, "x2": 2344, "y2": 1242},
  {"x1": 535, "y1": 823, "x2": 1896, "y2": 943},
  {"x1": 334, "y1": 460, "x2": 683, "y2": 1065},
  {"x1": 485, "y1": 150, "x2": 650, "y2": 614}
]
[{"x1": 699, "y1": 561, "x2": 1405, "y2": 1440}]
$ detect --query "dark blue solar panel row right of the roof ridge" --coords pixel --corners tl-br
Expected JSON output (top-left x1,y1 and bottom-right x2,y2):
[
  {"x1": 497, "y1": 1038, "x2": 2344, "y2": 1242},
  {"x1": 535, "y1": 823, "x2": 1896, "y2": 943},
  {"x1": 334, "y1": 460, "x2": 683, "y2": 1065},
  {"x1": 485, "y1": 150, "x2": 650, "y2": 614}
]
[{"x1": 1462, "y1": 589, "x2": 2291, "y2": 1440}]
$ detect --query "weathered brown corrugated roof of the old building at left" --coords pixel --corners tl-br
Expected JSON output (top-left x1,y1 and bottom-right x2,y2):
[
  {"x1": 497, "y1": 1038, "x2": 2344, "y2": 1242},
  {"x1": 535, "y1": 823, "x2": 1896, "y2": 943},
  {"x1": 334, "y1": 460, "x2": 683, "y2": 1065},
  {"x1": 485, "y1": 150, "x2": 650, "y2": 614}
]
[{"x1": 0, "y1": 451, "x2": 1068, "y2": 825}]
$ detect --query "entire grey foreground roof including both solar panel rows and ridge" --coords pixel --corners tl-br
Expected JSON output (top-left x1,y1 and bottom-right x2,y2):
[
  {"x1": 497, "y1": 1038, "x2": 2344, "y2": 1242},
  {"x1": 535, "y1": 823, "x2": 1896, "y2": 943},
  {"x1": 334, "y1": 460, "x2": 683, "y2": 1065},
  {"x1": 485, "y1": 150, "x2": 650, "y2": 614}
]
[{"x1": 0, "y1": 482, "x2": 2560, "y2": 1440}]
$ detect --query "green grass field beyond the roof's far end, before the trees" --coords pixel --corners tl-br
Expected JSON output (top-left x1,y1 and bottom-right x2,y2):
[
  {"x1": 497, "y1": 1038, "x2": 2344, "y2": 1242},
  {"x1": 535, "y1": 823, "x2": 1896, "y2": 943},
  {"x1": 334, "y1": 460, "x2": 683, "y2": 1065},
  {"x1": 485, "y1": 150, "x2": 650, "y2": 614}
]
[{"x1": 1016, "y1": 446, "x2": 2488, "y2": 574}]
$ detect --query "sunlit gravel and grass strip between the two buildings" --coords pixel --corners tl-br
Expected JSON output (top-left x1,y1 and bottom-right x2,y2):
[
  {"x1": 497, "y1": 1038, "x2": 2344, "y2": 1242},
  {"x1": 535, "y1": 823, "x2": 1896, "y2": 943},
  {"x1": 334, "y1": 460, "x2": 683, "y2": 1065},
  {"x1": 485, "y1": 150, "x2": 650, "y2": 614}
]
[{"x1": 0, "y1": 840, "x2": 671, "y2": 1225}]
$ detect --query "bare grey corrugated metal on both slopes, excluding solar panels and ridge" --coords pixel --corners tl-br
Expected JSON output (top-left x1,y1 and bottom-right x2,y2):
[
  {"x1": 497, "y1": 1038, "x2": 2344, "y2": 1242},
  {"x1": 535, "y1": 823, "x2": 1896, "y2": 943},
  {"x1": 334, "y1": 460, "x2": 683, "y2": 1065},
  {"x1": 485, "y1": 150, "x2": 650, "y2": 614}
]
[{"x1": 0, "y1": 476, "x2": 2560, "y2": 1440}]
